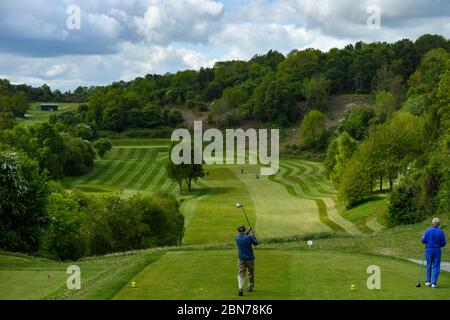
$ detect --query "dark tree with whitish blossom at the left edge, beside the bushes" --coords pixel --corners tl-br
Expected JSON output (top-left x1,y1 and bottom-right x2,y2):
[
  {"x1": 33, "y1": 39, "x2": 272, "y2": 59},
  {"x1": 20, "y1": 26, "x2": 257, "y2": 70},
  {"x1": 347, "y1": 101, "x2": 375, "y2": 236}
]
[{"x1": 0, "y1": 145, "x2": 50, "y2": 252}]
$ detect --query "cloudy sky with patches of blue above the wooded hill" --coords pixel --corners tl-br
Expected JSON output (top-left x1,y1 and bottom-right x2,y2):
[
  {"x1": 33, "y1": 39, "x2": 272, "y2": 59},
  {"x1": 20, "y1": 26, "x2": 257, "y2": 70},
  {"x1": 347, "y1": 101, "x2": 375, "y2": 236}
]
[{"x1": 0, "y1": 0, "x2": 450, "y2": 90}]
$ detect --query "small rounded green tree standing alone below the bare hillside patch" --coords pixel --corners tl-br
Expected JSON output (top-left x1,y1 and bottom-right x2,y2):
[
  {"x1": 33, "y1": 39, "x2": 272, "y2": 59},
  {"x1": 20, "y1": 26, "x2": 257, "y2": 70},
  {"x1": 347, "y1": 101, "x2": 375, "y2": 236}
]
[{"x1": 300, "y1": 110, "x2": 328, "y2": 151}]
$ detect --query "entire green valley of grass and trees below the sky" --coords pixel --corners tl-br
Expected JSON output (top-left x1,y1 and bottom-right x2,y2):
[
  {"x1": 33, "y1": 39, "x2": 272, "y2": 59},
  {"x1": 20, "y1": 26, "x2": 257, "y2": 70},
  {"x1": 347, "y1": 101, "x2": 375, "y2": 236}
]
[{"x1": 0, "y1": 35, "x2": 450, "y2": 300}]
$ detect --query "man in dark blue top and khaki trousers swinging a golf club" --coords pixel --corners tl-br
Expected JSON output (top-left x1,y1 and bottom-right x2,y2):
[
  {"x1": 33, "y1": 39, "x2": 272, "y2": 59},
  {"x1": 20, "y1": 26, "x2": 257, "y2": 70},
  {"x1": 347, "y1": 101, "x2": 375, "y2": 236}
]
[{"x1": 235, "y1": 226, "x2": 258, "y2": 296}]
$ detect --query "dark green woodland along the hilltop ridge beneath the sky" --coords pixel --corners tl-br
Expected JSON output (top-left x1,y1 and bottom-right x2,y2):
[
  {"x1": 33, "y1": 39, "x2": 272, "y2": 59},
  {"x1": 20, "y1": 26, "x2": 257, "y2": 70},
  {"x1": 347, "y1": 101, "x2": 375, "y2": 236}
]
[{"x1": 32, "y1": 35, "x2": 450, "y2": 135}]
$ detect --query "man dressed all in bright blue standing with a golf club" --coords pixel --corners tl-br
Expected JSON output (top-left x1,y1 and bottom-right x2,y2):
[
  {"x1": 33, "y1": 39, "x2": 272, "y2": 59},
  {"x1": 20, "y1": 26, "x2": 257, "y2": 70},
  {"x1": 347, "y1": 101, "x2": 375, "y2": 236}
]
[{"x1": 422, "y1": 218, "x2": 446, "y2": 288}]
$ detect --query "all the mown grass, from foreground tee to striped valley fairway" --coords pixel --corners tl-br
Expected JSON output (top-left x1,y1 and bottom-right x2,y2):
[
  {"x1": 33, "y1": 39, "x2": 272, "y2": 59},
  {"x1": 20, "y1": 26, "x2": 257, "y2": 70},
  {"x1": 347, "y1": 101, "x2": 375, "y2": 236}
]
[{"x1": 0, "y1": 139, "x2": 450, "y2": 299}]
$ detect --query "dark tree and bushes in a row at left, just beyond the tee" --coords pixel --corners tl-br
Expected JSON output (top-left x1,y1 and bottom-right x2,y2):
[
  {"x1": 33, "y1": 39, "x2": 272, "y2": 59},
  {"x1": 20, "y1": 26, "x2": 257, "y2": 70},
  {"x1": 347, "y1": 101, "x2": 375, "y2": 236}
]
[{"x1": 0, "y1": 145, "x2": 184, "y2": 260}]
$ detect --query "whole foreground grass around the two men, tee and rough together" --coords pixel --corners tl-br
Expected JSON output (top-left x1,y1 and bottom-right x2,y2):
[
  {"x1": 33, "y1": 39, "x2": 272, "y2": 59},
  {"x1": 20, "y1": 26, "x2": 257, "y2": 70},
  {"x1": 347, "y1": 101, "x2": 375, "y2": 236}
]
[{"x1": 0, "y1": 223, "x2": 450, "y2": 300}]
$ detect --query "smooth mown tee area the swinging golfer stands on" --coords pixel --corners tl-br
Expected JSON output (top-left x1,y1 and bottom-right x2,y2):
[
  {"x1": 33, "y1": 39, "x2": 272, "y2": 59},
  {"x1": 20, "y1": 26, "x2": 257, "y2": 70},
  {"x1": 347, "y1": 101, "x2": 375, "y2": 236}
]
[{"x1": 114, "y1": 250, "x2": 450, "y2": 300}]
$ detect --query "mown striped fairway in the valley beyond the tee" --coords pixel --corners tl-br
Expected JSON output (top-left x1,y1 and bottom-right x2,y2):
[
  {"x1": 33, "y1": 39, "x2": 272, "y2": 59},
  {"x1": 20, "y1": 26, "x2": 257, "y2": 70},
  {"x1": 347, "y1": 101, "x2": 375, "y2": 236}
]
[{"x1": 63, "y1": 140, "x2": 362, "y2": 244}]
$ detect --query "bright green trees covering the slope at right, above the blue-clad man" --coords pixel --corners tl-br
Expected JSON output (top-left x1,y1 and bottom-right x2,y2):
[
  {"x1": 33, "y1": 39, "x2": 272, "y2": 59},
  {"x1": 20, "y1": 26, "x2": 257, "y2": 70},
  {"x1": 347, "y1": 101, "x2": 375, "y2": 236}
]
[{"x1": 300, "y1": 47, "x2": 450, "y2": 226}]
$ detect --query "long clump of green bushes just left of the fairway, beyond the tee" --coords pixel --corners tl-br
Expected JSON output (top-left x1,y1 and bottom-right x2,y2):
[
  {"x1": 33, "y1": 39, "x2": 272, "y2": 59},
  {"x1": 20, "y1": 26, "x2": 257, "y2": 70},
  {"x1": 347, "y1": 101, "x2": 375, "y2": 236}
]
[{"x1": 40, "y1": 188, "x2": 184, "y2": 260}]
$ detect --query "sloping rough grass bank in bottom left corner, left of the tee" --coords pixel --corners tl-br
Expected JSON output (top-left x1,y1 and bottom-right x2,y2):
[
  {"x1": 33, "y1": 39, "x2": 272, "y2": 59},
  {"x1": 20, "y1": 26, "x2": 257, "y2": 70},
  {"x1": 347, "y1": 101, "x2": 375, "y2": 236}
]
[{"x1": 0, "y1": 250, "x2": 164, "y2": 300}]
